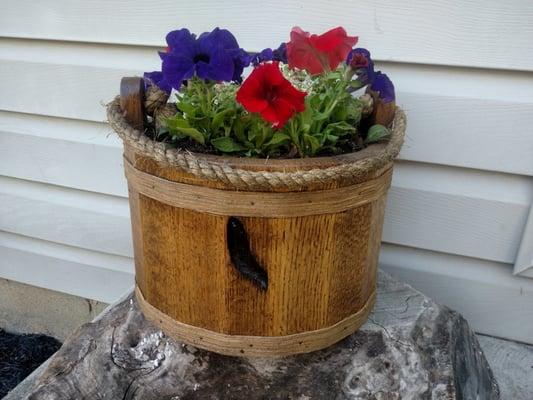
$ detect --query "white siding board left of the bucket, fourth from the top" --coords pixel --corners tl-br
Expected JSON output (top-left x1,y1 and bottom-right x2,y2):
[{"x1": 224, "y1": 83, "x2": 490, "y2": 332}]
[{"x1": 0, "y1": 177, "x2": 133, "y2": 256}]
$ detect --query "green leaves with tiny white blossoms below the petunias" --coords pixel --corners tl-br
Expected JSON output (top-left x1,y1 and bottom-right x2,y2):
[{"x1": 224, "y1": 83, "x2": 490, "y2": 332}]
[{"x1": 159, "y1": 69, "x2": 374, "y2": 157}]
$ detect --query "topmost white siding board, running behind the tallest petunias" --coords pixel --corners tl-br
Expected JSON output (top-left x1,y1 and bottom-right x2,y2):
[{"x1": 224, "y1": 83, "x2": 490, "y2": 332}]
[{"x1": 0, "y1": 0, "x2": 533, "y2": 70}]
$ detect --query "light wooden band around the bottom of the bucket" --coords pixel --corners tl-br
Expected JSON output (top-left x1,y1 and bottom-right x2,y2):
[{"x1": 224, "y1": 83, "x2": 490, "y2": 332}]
[{"x1": 135, "y1": 286, "x2": 376, "y2": 357}]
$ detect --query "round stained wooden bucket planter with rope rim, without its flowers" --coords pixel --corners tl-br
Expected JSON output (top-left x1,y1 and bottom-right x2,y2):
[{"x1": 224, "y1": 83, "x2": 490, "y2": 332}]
[{"x1": 108, "y1": 78, "x2": 405, "y2": 356}]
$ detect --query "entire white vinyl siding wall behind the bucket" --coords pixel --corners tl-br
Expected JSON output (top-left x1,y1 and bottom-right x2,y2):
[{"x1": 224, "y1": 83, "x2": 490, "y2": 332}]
[{"x1": 0, "y1": 0, "x2": 533, "y2": 342}]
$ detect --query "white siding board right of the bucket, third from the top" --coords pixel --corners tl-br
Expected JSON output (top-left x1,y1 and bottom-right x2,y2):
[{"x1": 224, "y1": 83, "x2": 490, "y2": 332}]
[{"x1": 383, "y1": 162, "x2": 533, "y2": 263}]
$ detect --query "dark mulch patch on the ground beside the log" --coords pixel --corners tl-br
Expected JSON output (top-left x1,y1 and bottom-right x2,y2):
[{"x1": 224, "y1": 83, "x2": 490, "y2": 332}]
[{"x1": 0, "y1": 329, "x2": 61, "y2": 399}]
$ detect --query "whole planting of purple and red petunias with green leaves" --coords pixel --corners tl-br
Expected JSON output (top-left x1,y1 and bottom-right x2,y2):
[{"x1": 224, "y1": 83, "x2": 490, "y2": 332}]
[{"x1": 144, "y1": 27, "x2": 395, "y2": 158}]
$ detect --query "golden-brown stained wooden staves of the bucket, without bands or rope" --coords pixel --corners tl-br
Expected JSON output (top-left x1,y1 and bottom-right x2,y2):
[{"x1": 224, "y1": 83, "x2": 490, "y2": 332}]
[{"x1": 125, "y1": 141, "x2": 390, "y2": 344}]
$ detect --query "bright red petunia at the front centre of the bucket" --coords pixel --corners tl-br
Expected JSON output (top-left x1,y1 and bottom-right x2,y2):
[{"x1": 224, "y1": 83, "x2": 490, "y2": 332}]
[{"x1": 237, "y1": 61, "x2": 307, "y2": 128}]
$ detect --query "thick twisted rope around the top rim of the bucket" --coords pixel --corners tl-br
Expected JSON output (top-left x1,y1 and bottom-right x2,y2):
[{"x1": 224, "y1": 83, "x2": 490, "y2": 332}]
[{"x1": 107, "y1": 97, "x2": 406, "y2": 191}]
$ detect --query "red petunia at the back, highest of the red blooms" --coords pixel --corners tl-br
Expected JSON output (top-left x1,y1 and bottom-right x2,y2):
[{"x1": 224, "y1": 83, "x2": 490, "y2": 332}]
[{"x1": 287, "y1": 26, "x2": 358, "y2": 75}]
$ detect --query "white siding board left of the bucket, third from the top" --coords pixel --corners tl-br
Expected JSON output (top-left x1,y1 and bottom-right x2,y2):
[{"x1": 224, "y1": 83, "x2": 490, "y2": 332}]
[{"x1": 0, "y1": 111, "x2": 128, "y2": 196}]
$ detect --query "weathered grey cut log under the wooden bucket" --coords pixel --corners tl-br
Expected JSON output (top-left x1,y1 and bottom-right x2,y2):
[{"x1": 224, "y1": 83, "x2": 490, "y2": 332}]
[{"x1": 6, "y1": 273, "x2": 500, "y2": 400}]
